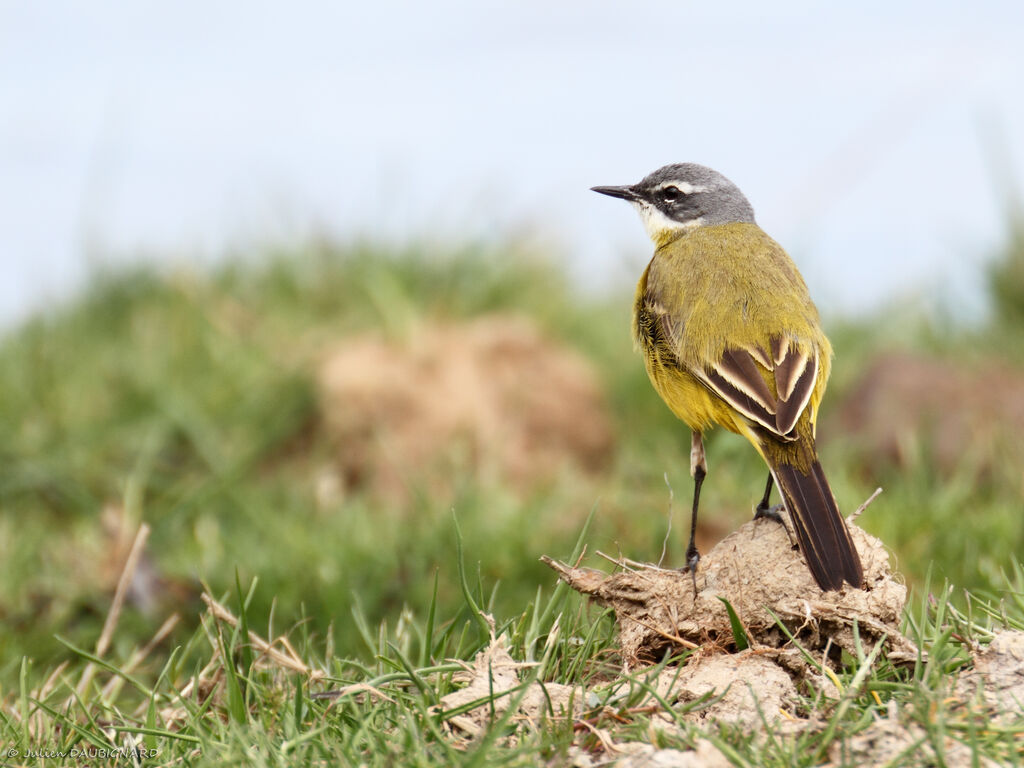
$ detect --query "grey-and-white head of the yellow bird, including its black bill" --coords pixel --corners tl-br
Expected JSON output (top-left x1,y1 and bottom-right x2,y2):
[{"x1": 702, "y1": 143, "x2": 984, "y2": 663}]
[{"x1": 592, "y1": 163, "x2": 754, "y2": 240}]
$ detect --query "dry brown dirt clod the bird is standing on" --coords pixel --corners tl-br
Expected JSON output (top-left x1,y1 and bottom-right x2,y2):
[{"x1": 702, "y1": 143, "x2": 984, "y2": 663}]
[{"x1": 544, "y1": 512, "x2": 916, "y2": 672}]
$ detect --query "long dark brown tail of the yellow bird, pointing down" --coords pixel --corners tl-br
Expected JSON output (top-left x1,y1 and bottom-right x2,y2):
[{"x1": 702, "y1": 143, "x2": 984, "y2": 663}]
[{"x1": 771, "y1": 458, "x2": 864, "y2": 590}]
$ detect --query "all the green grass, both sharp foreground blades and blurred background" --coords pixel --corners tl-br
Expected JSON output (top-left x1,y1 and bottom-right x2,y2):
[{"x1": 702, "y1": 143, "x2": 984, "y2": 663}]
[{"x1": 0, "y1": 244, "x2": 1024, "y2": 765}]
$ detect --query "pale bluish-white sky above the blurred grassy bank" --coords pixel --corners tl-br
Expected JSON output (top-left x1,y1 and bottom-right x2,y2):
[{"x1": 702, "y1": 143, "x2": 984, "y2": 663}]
[{"x1": 0, "y1": 0, "x2": 1024, "y2": 324}]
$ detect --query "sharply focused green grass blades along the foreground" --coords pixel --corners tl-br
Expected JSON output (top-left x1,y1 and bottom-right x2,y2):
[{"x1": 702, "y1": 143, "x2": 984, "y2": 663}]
[{"x1": 0, "y1": 537, "x2": 1024, "y2": 766}]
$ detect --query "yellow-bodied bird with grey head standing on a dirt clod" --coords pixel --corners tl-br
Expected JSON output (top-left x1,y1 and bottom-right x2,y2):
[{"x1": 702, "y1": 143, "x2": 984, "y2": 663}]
[{"x1": 591, "y1": 163, "x2": 863, "y2": 596}]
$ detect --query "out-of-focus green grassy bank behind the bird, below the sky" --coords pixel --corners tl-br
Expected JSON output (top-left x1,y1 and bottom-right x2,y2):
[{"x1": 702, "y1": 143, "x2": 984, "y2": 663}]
[{"x1": 0, "y1": 223, "x2": 1024, "y2": 684}]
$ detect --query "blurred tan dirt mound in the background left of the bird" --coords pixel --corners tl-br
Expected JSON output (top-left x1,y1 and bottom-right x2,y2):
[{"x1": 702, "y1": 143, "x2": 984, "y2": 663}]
[{"x1": 318, "y1": 315, "x2": 612, "y2": 501}]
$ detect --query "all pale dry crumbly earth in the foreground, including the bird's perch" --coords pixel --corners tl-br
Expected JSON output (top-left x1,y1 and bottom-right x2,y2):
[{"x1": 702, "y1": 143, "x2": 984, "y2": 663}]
[{"x1": 419, "y1": 507, "x2": 1024, "y2": 768}]
